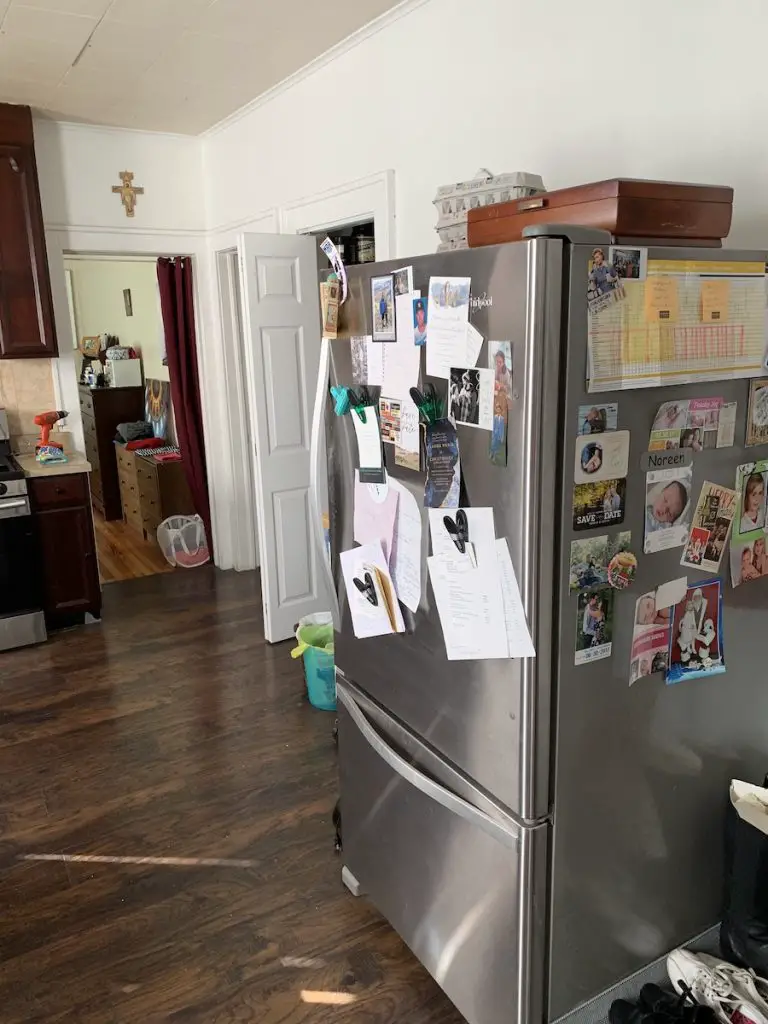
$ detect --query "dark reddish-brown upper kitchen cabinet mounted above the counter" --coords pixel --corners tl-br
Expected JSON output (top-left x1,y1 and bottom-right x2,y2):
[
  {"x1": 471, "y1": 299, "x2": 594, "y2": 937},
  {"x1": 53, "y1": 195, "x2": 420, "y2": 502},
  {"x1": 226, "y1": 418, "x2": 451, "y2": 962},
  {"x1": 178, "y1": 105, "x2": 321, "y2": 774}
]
[{"x1": 0, "y1": 103, "x2": 58, "y2": 359}]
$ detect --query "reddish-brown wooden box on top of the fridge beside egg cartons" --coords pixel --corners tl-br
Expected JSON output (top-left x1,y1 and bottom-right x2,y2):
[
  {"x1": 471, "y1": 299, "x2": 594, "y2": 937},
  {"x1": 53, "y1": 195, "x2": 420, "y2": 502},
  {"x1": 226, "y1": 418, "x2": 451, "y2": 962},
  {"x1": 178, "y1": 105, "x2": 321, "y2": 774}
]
[{"x1": 468, "y1": 178, "x2": 733, "y2": 248}]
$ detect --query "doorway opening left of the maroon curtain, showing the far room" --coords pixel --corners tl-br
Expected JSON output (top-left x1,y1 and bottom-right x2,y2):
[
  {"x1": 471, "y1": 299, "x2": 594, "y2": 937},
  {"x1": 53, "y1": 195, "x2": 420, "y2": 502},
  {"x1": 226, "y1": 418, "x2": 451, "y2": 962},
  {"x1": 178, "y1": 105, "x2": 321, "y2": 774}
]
[{"x1": 63, "y1": 253, "x2": 207, "y2": 585}]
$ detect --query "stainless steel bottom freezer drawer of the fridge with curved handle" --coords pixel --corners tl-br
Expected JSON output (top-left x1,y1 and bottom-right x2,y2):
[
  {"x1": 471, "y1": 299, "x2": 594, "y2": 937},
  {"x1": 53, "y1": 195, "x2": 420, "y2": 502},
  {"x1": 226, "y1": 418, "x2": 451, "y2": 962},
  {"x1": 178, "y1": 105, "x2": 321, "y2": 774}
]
[{"x1": 338, "y1": 684, "x2": 549, "y2": 1024}]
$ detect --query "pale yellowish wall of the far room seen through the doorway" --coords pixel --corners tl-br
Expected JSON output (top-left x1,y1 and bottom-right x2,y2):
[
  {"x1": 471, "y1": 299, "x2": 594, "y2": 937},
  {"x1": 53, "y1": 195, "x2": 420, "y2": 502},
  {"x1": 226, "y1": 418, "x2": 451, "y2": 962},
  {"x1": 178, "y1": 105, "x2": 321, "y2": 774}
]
[{"x1": 65, "y1": 257, "x2": 170, "y2": 381}]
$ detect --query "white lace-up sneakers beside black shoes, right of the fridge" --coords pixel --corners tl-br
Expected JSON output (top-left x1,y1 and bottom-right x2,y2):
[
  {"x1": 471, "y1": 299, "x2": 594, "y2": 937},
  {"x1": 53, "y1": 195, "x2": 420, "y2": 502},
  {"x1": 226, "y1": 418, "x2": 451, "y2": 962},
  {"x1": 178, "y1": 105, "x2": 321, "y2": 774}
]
[{"x1": 667, "y1": 949, "x2": 768, "y2": 1024}]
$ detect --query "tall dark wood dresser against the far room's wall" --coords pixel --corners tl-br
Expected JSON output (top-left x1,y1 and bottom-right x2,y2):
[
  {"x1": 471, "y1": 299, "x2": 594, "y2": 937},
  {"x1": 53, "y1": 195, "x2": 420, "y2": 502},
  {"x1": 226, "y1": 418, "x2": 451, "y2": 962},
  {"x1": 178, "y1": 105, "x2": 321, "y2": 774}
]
[{"x1": 80, "y1": 384, "x2": 144, "y2": 519}]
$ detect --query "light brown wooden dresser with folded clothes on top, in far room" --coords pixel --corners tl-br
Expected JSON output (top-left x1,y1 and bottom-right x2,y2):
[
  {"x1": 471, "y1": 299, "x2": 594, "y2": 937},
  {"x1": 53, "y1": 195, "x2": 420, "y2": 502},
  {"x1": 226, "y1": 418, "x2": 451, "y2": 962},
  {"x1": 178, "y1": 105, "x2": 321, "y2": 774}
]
[{"x1": 115, "y1": 444, "x2": 195, "y2": 541}]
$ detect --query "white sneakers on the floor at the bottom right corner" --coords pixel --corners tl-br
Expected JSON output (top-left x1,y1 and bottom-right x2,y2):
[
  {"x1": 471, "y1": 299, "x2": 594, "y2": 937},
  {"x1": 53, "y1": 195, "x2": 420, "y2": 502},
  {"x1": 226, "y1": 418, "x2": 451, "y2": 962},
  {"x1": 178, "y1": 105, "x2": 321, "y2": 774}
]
[{"x1": 667, "y1": 949, "x2": 768, "y2": 1024}]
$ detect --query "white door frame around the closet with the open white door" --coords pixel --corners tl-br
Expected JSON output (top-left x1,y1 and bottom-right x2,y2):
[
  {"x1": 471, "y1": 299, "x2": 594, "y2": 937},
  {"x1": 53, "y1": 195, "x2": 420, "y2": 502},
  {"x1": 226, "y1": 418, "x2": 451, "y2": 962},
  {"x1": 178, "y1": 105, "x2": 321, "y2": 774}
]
[{"x1": 215, "y1": 176, "x2": 395, "y2": 570}]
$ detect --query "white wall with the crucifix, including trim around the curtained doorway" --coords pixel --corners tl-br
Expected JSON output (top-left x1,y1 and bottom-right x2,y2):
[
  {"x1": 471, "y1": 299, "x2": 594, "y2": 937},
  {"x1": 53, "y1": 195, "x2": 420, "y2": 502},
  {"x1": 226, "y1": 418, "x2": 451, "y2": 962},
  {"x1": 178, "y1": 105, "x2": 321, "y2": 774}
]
[{"x1": 28, "y1": 119, "x2": 234, "y2": 568}]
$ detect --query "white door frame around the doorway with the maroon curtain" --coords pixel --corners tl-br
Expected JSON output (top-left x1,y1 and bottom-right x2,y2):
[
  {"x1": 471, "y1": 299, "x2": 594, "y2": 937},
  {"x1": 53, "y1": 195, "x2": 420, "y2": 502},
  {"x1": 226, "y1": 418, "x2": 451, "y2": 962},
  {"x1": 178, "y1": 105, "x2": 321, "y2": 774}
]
[{"x1": 45, "y1": 227, "x2": 227, "y2": 568}]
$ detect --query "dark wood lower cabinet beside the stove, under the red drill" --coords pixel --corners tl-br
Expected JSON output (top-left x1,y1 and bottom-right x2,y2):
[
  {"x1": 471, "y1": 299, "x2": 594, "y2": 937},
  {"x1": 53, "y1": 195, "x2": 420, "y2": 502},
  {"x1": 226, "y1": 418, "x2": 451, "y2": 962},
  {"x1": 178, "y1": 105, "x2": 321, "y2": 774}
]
[{"x1": 28, "y1": 473, "x2": 101, "y2": 629}]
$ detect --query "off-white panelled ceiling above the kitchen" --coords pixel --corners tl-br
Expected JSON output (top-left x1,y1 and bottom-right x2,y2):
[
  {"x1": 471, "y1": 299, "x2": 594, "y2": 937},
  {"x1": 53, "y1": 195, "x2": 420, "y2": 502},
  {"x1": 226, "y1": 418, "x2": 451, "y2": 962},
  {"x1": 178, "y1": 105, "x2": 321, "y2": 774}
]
[{"x1": 0, "y1": 0, "x2": 399, "y2": 134}]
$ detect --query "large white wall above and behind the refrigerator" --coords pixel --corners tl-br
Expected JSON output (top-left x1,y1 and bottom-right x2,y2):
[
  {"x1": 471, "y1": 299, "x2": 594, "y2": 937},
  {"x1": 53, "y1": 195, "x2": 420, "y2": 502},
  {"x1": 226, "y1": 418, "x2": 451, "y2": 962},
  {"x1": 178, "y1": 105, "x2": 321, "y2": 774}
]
[{"x1": 204, "y1": 0, "x2": 768, "y2": 249}]
